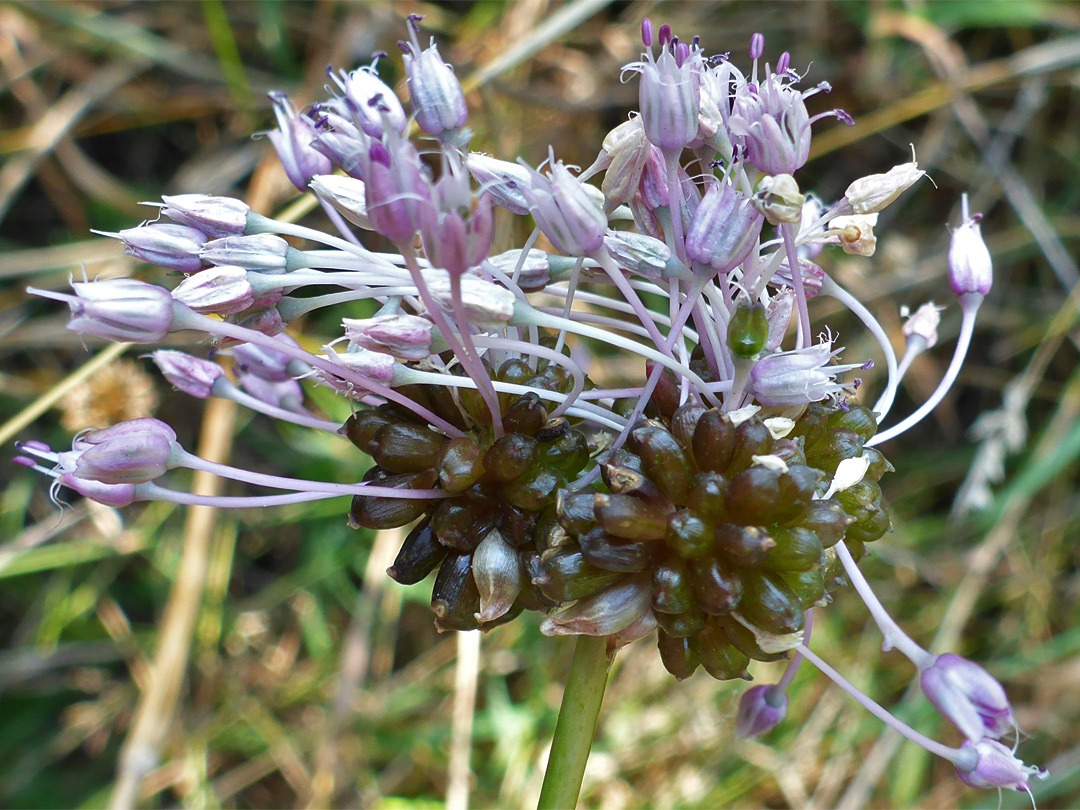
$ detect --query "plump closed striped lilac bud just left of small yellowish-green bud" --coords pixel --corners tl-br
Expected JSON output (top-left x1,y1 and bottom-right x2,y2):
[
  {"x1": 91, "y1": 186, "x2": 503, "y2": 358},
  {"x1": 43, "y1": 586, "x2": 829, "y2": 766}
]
[{"x1": 686, "y1": 180, "x2": 765, "y2": 273}]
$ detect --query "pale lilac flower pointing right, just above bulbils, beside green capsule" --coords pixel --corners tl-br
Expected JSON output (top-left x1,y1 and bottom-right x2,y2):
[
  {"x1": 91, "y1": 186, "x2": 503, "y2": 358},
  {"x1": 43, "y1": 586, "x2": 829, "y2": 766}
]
[{"x1": 750, "y1": 340, "x2": 860, "y2": 406}]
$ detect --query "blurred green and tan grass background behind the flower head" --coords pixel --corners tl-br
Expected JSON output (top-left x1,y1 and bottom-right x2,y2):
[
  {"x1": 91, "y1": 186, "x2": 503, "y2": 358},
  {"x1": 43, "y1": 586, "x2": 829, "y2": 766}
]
[{"x1": 0, "y1": 0, "x2": 1080, "y2": 809}]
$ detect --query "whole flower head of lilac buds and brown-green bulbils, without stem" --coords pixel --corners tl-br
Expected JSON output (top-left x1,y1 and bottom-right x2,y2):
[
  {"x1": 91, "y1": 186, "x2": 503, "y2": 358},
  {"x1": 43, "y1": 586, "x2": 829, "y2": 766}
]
[{"x1": 17, "y1": 17, "x2": 1042, "y2": 803}]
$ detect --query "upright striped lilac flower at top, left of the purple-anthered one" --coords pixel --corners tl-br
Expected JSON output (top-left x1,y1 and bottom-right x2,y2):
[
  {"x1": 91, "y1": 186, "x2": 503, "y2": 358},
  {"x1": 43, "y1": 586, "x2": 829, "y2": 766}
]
[{"x1": 623, "y1": 29, "x2": 702, "y2": 153}]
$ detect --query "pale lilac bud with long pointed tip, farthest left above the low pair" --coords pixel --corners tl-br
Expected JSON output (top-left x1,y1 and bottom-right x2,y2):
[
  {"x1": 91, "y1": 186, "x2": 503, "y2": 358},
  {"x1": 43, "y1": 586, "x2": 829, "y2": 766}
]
[{"x1": 27, "y1": 279, "x2": 173, "y2": 343}]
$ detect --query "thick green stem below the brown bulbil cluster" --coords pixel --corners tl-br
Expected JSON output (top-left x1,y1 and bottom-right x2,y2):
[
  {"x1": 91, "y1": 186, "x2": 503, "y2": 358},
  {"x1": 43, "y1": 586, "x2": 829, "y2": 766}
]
[{"x1": 537, "y1": 636, "x2": 610, "y2": 810}]
